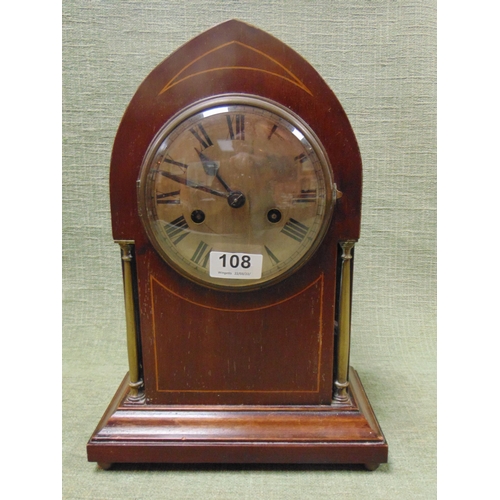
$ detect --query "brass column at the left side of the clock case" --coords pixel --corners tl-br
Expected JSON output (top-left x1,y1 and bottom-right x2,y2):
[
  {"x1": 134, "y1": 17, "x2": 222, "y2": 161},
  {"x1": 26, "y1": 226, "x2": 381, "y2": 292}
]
[{"x1": 117, "y1": 241, "x2": 144, "y2": 404}]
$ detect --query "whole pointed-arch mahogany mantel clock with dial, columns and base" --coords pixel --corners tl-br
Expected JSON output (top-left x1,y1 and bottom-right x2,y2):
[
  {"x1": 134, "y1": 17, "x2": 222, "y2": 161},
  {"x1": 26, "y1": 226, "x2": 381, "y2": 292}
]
[{"x1": 87, "y1": 20, "x2": 388, "y2": 469}]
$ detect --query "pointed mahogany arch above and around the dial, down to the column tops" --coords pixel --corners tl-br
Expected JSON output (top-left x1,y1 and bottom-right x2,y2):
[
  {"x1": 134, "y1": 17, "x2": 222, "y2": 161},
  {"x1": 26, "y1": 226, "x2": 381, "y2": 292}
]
[{"x1": 110, "y1": 20, "x2": 362, "y2": 242}]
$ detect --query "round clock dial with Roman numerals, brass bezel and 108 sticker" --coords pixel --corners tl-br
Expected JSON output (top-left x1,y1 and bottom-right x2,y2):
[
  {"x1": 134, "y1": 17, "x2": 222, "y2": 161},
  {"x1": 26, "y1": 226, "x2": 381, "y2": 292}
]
[{"x1": 139, "y1": 96, "x2": 333, "y2": 290}]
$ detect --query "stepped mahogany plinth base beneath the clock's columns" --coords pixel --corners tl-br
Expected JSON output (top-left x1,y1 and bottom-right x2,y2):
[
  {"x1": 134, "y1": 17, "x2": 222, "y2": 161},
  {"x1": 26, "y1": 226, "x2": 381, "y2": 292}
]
[{"x1": 87, "y1": 368, "x2": 388, "y2": 470}]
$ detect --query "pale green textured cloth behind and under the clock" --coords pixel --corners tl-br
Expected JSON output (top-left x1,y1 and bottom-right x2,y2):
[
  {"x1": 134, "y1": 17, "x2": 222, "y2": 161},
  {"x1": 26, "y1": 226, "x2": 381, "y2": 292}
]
[{"x1": 63, "y1": 0, "x2": 436, "y2": 500}]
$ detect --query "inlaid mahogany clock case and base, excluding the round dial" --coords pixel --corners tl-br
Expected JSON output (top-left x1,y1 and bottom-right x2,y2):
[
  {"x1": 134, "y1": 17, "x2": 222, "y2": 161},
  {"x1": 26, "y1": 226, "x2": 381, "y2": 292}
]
[{"x1": 87, "y1": 20, "x2": 387, "y2": 468}]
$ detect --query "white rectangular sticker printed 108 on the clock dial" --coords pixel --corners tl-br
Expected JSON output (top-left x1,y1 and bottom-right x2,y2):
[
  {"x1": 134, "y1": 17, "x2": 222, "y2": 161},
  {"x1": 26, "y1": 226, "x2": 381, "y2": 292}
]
[{"x1": 210, "y1": 252, "x2": 262, "y2": 280}]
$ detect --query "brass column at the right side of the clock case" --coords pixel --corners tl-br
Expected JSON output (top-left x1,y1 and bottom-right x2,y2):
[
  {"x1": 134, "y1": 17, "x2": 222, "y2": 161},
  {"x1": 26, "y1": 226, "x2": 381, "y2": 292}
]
[{"x1": 333, "y1": 241, "x2": 355, "y2": 403}]
